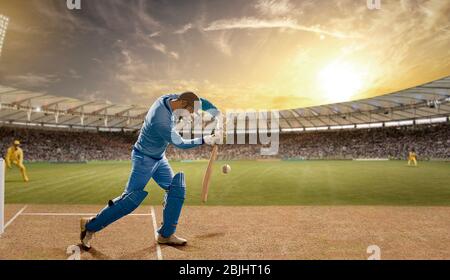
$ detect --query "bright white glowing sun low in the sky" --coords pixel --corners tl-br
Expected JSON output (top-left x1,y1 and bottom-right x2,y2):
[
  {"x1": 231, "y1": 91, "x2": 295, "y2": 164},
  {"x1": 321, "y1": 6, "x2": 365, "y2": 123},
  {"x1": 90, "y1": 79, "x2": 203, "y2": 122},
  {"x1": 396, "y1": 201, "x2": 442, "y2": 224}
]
[{"x1": 318, "y1": 61, "x2": 362, "y2": 102}]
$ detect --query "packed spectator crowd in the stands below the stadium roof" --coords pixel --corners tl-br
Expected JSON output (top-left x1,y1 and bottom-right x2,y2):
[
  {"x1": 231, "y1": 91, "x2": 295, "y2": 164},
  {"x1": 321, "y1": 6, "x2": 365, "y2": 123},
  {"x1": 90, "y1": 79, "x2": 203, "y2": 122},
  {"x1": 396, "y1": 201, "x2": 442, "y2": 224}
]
[{"x1": 0, "y1": 123, "x2": 450, "y2": 162}]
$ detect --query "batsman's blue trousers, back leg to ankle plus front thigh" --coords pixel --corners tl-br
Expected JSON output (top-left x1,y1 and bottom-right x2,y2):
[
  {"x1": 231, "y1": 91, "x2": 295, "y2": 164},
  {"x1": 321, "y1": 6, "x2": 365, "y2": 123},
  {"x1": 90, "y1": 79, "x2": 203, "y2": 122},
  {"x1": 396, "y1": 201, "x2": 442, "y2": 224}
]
[{"x1": 86, "y1": 149, "x2": 174, "y2": 232}]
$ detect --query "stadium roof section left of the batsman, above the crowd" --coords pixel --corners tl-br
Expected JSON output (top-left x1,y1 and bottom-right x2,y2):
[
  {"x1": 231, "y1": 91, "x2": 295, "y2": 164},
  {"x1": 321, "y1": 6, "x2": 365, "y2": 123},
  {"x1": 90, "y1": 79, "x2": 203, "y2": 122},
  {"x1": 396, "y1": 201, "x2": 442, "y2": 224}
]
[{"x1": 0, "y1": 86, "x2": 148, "y2": 129}]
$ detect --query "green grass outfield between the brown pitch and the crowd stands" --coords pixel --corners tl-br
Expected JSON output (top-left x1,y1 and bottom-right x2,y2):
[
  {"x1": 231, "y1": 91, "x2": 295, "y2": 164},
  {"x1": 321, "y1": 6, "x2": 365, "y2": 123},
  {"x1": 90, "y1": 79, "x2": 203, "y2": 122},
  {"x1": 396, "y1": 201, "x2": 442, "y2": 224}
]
[{"x1": 6, "y1": 161, "x2": 450, "y2": 206}]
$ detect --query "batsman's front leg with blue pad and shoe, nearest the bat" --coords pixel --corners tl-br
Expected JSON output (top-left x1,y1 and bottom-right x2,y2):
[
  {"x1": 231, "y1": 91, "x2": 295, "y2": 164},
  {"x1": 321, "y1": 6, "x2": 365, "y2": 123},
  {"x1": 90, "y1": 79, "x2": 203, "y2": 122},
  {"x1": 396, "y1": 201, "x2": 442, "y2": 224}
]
[{"x1": 153, "y1": 159, "x2": 187, "y2": 245}]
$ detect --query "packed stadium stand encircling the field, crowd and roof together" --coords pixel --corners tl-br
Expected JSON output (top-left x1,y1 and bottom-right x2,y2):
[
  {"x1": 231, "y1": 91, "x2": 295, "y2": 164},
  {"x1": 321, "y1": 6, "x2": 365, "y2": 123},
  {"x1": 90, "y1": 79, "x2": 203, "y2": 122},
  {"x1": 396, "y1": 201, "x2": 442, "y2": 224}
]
[{"x1": 0, "y1": 77, "x2": 450, "y2": 162}]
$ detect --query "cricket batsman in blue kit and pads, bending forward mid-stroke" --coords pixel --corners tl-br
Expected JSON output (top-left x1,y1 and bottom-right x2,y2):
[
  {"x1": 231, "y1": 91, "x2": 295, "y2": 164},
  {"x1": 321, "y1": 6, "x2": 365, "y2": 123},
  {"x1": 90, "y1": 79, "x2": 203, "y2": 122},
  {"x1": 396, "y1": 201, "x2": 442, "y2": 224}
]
[{"x1": 80, "y1": 92, "x2": 220, "y2": 249}]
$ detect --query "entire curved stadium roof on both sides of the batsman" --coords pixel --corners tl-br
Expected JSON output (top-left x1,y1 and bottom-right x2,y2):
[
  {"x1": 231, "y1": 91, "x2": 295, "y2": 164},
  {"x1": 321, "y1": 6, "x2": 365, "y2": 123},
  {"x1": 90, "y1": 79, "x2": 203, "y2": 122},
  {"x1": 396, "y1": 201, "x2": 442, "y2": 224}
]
[{"x1": 0, "y1": 76, "x2": 450, "y2": 131}]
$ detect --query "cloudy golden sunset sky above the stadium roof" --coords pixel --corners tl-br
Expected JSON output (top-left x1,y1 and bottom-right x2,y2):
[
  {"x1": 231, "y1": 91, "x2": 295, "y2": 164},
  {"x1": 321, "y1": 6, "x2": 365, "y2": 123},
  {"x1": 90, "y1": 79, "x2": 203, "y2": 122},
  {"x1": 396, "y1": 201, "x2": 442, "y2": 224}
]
[{"x1": 0, "y1": 0, "x2": 450, "y2": 109}]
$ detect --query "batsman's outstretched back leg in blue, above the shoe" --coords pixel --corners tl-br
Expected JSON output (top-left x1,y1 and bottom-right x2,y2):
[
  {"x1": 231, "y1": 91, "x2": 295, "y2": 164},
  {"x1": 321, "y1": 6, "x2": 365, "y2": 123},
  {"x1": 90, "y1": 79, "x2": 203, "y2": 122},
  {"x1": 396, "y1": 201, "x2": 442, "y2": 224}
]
[{"x1": 86, "y1": 151, "x2": 159, "y2": 232}]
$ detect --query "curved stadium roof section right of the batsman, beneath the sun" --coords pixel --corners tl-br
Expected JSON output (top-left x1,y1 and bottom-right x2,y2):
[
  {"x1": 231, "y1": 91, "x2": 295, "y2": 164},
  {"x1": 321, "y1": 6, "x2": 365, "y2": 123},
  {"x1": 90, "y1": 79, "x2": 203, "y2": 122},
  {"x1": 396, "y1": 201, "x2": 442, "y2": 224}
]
[{"x1": 280, "y1": 76, "x2": 450, "y2": 129}]
